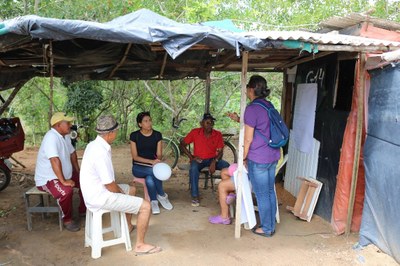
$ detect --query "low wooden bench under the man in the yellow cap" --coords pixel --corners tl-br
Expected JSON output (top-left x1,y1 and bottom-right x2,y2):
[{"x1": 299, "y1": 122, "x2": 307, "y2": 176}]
[{"x1": 24, "y1": 186, "x2": 63, "y2": 231}]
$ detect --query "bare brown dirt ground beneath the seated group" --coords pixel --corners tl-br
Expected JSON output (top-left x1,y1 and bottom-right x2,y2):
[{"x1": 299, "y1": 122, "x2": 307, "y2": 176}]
[{"x1": 0, "y1": 145, "x2": 398, "y2": 265}]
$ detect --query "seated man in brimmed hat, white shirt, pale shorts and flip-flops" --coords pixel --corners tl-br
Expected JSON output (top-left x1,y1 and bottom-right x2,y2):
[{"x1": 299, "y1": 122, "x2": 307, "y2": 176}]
[{"x1": 81, "y1": 115, "x2": 161, "y2": 255}]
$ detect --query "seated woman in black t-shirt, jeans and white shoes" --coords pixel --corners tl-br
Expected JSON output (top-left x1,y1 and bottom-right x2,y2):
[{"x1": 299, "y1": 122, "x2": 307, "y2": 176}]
[{"x1": 130, "y1": 112, "x2": 173, "y2": 214}]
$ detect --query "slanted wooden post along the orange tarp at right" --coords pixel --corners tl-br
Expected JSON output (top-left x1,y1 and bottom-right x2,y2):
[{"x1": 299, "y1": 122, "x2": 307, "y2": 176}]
[{"x1": 345, "y1": 52, "x2": 365, "y2": 236}]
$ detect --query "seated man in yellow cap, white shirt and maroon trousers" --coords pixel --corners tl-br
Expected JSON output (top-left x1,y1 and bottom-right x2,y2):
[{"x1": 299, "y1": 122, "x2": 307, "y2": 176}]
[{"x1": 35, "y1": 112, "x2": 86, "y2": 232}]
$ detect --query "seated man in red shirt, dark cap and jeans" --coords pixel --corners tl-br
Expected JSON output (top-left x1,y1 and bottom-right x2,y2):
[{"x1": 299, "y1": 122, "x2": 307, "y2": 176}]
[{"x1": 180, "y1": 113, "x2": 229, "y2": 207}]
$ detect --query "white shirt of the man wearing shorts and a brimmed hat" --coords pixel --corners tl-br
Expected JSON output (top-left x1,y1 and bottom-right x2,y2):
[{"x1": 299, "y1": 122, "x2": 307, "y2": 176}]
[{"x1": 80, "y1": 136, "x2": 115, "y2": 211}]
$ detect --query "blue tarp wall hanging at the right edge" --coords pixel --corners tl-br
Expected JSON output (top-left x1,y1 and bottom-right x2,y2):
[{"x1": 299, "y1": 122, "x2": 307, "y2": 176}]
[{"x1": 360, "y1": 64, "x2": 400, "y2": 263}]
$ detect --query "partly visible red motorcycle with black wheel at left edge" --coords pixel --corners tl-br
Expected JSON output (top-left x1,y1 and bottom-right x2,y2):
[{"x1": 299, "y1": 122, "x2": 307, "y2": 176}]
[{"x1": 0, "y1": 117, "x2": 25, "y2": 191}]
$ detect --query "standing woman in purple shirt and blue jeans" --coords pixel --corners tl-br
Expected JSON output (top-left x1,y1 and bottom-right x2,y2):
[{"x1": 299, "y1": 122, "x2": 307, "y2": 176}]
[{"x1": 243, "y1": 75, "x2": 280, "y2": 237}]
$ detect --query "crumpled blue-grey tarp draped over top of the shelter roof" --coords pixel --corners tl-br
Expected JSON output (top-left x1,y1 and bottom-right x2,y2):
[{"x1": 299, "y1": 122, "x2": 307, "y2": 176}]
[{"x1": 0, "y1": 9, "x2": 257, "y2": 59}]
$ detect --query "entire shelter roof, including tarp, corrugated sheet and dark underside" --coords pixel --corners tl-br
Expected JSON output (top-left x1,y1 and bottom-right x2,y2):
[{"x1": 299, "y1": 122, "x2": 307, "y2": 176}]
[{"x1": 0, "y1": 9, "x2": 400, "y2": 91}]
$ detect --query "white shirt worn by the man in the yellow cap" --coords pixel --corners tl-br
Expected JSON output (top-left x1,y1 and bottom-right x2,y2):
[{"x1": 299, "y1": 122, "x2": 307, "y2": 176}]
[{"x1": 35, "y1": 128, "x2": 75, "y2": 186}]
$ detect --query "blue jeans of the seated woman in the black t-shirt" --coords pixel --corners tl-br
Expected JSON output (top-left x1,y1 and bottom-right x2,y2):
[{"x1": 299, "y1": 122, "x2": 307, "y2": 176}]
[{"x1": 132, "y1": 164, "x2": 165, "y2": 200}]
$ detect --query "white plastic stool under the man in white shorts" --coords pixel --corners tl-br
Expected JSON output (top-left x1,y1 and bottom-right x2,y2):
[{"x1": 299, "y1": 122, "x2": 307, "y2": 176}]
[{"x1": 85, "y1": 209, "x2": 132, "y2": 259}]
